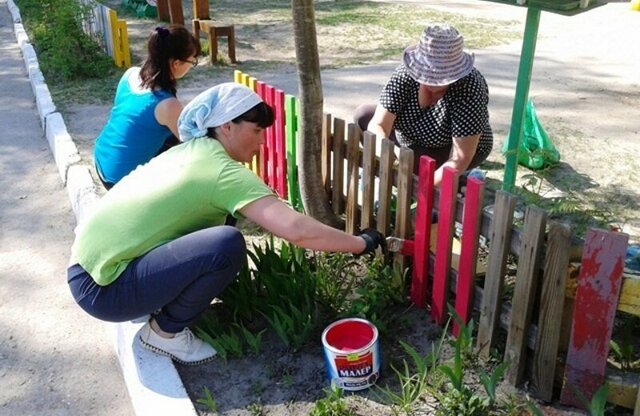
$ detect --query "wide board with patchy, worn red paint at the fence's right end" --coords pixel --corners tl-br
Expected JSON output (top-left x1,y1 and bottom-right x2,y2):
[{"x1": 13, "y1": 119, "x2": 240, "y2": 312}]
[{"x1": 560, "y1": 229, "x2": 629, "y2": 406}]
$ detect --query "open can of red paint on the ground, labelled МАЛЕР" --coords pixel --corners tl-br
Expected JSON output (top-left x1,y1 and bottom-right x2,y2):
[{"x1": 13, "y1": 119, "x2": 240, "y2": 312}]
[{"x1": 322, "y1": 318, "x2": 380, "y2": 391}]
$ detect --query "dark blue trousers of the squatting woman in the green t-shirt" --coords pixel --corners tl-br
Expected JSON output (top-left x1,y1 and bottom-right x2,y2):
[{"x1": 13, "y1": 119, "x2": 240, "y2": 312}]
[{"x1": 67, "y1": 225, "x2": 246, "y2": 333}]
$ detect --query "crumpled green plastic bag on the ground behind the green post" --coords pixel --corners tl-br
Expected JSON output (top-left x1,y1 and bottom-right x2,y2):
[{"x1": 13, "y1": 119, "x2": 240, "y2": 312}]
[{"x1": 502, "y1": 100, "x2": 560, "y2": 170}]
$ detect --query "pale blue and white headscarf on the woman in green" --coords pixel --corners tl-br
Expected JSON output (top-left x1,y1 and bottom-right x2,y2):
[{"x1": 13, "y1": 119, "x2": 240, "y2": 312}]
[{"x1": 178, "y1": 82, "x2": 262, "y2": 142}]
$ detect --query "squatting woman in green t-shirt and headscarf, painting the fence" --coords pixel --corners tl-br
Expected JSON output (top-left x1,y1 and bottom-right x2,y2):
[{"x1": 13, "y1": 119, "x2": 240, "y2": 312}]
[{"x1": 67, "y1": 83, "x2": 384, "y2": 365}]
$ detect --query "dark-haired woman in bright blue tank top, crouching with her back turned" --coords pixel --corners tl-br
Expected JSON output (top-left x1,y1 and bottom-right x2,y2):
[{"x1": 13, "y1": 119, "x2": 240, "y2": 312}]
[{"x1": 94, "y1": 26, "x2": 200, "y2": 189}]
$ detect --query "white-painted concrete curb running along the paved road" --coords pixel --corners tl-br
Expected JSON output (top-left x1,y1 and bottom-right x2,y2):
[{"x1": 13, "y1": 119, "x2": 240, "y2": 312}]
[{"x1": 7, "y1": 0, "x2": 197, "y2": 416}]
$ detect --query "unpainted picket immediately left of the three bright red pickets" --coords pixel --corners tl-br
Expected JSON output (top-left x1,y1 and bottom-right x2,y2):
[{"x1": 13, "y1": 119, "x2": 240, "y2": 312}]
[{"x1": 394, "y1": 147, "x2": 413, "y2": 273}]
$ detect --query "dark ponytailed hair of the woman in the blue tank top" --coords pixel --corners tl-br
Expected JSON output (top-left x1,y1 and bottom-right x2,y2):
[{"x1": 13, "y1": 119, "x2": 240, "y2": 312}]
[{"x1": 140, "y1": 25, "x2": 200, "y2": 96}]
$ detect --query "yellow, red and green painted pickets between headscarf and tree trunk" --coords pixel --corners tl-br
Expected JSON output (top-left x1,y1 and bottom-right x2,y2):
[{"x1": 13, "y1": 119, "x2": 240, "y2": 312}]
[{"x1": 234, "y1": 70, "x2": 302, "y2": 210}]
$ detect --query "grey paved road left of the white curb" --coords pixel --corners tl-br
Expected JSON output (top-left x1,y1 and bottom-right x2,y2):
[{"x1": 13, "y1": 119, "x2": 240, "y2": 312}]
[{"x1": 0, "y1": 0, "x2": 133, "y2": 416}]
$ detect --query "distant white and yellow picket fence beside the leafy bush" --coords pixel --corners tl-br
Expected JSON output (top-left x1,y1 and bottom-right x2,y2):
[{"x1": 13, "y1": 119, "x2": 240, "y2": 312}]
[{"x1": 80, "y1": 0, "x2": 131, "y2": 68}]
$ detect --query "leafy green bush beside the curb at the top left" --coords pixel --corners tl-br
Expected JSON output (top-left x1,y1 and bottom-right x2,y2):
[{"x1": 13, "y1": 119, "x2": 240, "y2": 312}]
[{"x1": 17, "y1": 0, "x2": 114, "y2": 81}]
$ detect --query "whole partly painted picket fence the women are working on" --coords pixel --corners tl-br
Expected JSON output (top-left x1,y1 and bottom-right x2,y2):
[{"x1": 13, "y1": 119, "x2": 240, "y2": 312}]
[{"x1": 236, "y1": 72, "x2": 640, "y2": 416}]
